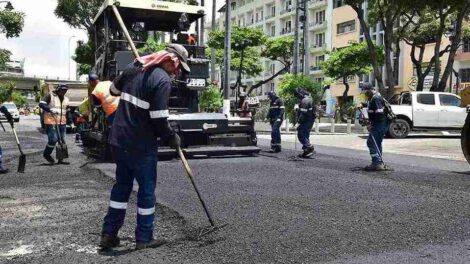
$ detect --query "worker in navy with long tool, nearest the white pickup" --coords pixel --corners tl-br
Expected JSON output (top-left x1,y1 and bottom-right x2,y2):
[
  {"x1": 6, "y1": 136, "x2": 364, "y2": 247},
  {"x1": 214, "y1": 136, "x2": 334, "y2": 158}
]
[{"x1": 361, "y1": 83, "x2": 390, "y2": 171}]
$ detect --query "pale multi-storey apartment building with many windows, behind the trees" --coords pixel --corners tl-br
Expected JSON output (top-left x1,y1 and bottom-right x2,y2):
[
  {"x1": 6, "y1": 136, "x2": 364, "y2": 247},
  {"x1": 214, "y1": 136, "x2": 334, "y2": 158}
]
[{"x1": 205, "y1": 0, "x2": 333, "y2": 96}]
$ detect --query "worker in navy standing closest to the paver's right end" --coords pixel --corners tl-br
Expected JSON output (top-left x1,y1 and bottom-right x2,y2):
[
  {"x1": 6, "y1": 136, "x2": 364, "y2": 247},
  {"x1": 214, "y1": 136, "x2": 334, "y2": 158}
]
[{"x1": 268, "y1": 91, "x2": 285, "y2": 152}]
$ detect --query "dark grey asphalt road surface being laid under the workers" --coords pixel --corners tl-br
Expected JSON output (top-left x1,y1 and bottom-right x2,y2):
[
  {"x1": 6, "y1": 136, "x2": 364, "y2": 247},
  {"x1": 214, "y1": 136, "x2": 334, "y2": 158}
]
[{"x1": 0, "y1": 118, "x2": 470, "y2": 263}]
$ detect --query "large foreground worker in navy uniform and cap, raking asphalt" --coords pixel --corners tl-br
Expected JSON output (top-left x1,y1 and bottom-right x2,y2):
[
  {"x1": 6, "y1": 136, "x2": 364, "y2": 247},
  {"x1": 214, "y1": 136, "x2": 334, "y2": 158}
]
[{"x1": 100, "y1": 44, "x2": 190, "y2": 250}]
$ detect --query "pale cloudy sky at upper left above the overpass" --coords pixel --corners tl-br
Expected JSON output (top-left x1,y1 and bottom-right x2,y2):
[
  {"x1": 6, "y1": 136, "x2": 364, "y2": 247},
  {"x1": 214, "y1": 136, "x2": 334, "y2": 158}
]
[{"x1": 0, "y1": 0, "x2": 225, "y2": 79}]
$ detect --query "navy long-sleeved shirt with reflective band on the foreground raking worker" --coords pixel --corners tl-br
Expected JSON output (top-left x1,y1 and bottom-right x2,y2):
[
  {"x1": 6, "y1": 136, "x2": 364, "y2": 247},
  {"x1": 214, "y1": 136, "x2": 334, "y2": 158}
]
[{"x1": 109, "y1": 64, "x2": 174, "y2": 154}]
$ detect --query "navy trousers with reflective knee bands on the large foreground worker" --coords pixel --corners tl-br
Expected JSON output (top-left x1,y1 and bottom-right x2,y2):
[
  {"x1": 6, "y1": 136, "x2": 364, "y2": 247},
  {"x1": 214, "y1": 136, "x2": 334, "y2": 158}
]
[{"x1": 102, "y1": 147, "x2": 157, "y2": 241}]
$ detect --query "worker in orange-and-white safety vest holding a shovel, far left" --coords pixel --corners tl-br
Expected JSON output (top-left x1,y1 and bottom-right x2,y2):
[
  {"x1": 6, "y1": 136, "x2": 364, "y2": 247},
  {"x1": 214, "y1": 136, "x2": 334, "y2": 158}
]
[{"x1": 39, "y1": 84, "x2": 69, "y2": 164}]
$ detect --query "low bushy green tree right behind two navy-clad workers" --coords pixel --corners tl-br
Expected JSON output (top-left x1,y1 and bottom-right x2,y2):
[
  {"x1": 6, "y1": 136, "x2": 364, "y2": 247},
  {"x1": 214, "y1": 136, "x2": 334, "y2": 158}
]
[{"x1": 279, "y1": 74, "x2": 322, "y2": 123}]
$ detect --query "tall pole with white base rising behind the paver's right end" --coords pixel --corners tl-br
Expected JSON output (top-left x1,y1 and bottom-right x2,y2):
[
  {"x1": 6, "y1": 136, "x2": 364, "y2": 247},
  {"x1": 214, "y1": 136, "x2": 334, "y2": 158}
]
[{"x1": 223, "y1": 0, "x2": 232, "y2": 116}]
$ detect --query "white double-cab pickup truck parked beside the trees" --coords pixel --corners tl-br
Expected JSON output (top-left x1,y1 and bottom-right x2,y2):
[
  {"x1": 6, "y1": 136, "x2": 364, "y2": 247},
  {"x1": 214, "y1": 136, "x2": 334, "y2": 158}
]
[{"x1": 389, "y1": 92, "x2": 467, "y2": 138}]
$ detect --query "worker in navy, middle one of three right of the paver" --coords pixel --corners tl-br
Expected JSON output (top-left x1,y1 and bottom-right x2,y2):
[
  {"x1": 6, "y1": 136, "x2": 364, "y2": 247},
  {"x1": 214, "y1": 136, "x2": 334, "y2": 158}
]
[{"x1": 294, "y1": 88, "x2": 316, "y2": 158}]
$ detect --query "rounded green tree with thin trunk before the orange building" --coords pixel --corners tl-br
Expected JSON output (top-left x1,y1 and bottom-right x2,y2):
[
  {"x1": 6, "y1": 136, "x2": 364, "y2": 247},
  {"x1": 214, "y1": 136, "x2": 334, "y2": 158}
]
[{"x1": 322, "y1": 41, "x2": 384, "y2": 103}]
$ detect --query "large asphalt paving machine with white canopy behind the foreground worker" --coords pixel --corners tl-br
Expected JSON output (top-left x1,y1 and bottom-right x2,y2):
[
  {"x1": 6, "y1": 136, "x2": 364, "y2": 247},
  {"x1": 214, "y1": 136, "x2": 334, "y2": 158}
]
[{"x1": 83, "y1": 0, "x2": 260, "y2": 159}]
